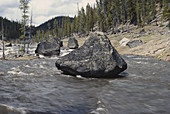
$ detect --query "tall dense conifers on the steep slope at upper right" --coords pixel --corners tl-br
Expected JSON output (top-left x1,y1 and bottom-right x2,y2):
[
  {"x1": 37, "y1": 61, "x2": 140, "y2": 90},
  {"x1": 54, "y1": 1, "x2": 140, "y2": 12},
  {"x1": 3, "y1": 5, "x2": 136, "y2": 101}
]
[{"x1": 74, "y1": 0, "x2": 170, "y2": 33}]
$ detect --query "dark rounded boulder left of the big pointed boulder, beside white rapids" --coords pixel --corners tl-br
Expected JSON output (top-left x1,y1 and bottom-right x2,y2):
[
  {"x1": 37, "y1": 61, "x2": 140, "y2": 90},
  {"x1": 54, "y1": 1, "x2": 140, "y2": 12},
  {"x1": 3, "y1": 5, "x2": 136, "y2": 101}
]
[{"x1": 35, "y1": 36, "x2": 61, "y2": 56}]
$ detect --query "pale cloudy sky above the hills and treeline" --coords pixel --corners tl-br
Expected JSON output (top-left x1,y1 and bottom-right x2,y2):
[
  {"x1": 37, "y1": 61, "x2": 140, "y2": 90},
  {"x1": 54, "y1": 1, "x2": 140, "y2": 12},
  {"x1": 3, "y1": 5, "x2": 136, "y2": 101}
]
[{"x1": 0, "y1": 0, "x2": 96, "y2": 26}]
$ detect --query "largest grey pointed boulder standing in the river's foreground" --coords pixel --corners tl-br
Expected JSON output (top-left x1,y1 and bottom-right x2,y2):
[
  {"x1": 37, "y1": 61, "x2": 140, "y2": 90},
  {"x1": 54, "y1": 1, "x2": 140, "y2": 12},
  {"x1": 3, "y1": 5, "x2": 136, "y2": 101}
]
[{"x1": 56, "y1": 32, "x2": 127, "y2": 78}]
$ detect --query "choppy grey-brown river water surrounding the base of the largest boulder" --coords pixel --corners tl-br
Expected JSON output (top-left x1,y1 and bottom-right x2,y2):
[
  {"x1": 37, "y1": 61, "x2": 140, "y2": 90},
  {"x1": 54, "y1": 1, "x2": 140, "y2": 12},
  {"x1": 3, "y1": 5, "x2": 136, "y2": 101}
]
[{"x1": 0, "y1": 55, "x2": 170, "y2": 114}]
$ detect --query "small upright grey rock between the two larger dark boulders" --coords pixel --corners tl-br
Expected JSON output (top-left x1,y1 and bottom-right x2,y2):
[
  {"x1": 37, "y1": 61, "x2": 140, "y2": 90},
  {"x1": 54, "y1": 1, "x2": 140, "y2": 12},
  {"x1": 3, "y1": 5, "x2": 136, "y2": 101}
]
[{"x1": 68, "y1": 38, "x2": 79, "y2": 49}]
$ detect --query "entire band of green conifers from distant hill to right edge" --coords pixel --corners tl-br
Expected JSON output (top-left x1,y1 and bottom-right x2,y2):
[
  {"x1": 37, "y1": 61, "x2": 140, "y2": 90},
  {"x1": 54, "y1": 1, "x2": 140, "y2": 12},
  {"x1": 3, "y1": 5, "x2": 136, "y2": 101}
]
[{"x1": 32, "y1": 0, "x2": 170, "y2": 40}]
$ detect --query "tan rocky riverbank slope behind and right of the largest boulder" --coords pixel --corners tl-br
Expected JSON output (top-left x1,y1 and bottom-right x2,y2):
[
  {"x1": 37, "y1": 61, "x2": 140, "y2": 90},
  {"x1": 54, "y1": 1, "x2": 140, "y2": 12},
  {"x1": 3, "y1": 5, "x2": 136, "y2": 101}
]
[{"x1": 63, "y1": 26, "x2": 170, "y2": 61}]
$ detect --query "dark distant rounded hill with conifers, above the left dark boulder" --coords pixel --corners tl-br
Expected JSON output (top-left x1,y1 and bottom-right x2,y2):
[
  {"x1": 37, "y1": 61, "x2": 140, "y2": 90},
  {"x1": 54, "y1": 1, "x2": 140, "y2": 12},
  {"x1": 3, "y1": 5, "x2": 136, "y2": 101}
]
[{"x1": 34, "y1": 16, "x2": 73, "y2": 40}]
